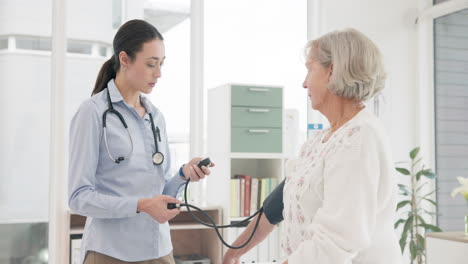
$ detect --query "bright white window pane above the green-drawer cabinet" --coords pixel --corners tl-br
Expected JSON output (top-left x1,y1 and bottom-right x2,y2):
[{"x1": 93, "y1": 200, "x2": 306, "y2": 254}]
[{"x1": 205, "y1": 0, "x2": 308, "y2": 139}]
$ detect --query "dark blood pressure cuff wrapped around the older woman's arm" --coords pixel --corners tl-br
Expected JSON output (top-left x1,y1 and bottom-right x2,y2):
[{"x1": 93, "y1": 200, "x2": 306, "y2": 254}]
[{"x1": 263, "y1": 177, "x2": 285, "y2": 225}]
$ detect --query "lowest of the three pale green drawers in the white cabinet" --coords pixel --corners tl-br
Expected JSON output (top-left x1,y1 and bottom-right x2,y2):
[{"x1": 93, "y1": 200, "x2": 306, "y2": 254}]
[{"x1": 231, "y1": 127, "x2": 283, "y2": 152}]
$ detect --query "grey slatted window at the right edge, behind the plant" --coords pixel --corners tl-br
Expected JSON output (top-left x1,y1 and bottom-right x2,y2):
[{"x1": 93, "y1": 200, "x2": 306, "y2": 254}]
[{"x1": 434, "y1": 9, "x2": 468, "y2": 231}]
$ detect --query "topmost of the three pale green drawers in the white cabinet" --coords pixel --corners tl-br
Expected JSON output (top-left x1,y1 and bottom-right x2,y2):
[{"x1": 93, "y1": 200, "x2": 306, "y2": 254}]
[{"x1": 231, "y1": 85, "x2": 283, "y2": 107}]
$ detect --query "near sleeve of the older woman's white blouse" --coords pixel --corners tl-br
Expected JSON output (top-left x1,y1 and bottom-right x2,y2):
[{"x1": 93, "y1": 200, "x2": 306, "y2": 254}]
[{"x1": 288, "y1": 127, "x2": 380, "y2": 264}]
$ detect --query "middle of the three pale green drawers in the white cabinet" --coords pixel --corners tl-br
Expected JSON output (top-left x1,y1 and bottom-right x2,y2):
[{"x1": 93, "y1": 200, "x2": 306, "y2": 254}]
[{"x1": 231, "y1": 106, "x2": 282, "y2": 127}]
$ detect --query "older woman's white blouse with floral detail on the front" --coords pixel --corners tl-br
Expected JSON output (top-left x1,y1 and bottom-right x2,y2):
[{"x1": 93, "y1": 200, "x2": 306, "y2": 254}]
[{"x1": 281, "y1": 109, "x2": 402, "y2": 264}]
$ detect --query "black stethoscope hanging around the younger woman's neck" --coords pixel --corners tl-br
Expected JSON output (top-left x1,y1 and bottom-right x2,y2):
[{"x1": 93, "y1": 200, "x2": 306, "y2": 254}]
[{"x1": 102, "y1": 88, "x2": 164, "y2": 165}]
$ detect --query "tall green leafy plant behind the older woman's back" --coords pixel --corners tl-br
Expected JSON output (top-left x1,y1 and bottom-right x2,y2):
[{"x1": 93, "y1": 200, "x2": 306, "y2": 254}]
[{"x1": 395, "y1": 147, "x2": 442, "y2": 264}]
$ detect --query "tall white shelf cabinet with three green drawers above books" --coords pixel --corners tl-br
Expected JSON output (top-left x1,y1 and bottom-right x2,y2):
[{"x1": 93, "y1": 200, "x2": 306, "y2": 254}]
[{"x1": 207, "y1": 84, "x2": 285, "y2": 263}]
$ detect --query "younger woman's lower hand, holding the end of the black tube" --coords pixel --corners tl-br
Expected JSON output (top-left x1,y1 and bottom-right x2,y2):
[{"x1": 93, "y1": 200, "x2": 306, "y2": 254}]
[{"x1": 137, "y1": 195, "x2": 182, "y2": 224}]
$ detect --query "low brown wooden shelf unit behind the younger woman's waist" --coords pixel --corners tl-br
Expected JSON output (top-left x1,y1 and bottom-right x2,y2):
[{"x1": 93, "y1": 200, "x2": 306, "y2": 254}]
[{"x1": 68, "y1": 206, "x2": 223, "y2": 264}]
